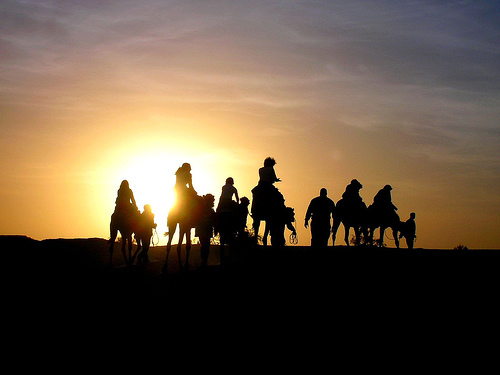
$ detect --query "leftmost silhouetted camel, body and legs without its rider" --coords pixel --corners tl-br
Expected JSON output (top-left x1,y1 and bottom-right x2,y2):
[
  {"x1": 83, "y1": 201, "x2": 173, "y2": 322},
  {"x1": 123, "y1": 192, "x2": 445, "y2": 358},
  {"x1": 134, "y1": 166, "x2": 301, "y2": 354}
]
[{"x1": 109, "y1": 210, "x2": 140, "y2": 267}]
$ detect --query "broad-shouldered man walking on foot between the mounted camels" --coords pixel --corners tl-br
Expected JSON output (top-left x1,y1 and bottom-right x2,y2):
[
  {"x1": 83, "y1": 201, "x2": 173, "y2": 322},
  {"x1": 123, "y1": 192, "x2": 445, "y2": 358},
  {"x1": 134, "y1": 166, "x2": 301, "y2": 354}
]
[{"x1": 304, "y1": 188, "x2": 335, "y2": 249}]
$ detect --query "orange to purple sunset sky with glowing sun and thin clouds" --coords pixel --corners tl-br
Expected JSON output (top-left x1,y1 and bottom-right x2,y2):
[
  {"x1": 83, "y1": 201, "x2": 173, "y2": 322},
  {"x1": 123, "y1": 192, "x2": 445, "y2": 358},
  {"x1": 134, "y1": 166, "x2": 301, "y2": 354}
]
[{"x1": 0, "y1": 0, "x2": 500, "y2": 249}]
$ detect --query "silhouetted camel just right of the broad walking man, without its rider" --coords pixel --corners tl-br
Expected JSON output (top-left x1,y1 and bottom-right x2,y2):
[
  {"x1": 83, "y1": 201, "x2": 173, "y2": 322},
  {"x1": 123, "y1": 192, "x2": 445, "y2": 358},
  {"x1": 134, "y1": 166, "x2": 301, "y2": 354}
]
[{"x1": 332, "y1": 199, "x2": 368, "y2": 246}]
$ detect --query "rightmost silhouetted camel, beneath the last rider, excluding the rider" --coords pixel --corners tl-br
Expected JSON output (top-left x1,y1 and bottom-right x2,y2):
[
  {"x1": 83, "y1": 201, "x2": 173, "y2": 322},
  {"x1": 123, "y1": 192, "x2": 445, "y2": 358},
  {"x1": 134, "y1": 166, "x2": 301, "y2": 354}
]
[{"x1": 366, "y1": 205, "x2": 401, "y2": 249}]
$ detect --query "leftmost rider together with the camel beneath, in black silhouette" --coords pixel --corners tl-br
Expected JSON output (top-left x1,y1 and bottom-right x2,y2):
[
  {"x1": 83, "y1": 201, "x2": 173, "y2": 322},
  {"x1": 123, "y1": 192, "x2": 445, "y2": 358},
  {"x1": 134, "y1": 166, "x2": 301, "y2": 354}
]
[{"x1": 109, "y1": 180, "x2": 139, "y2": 266}]
